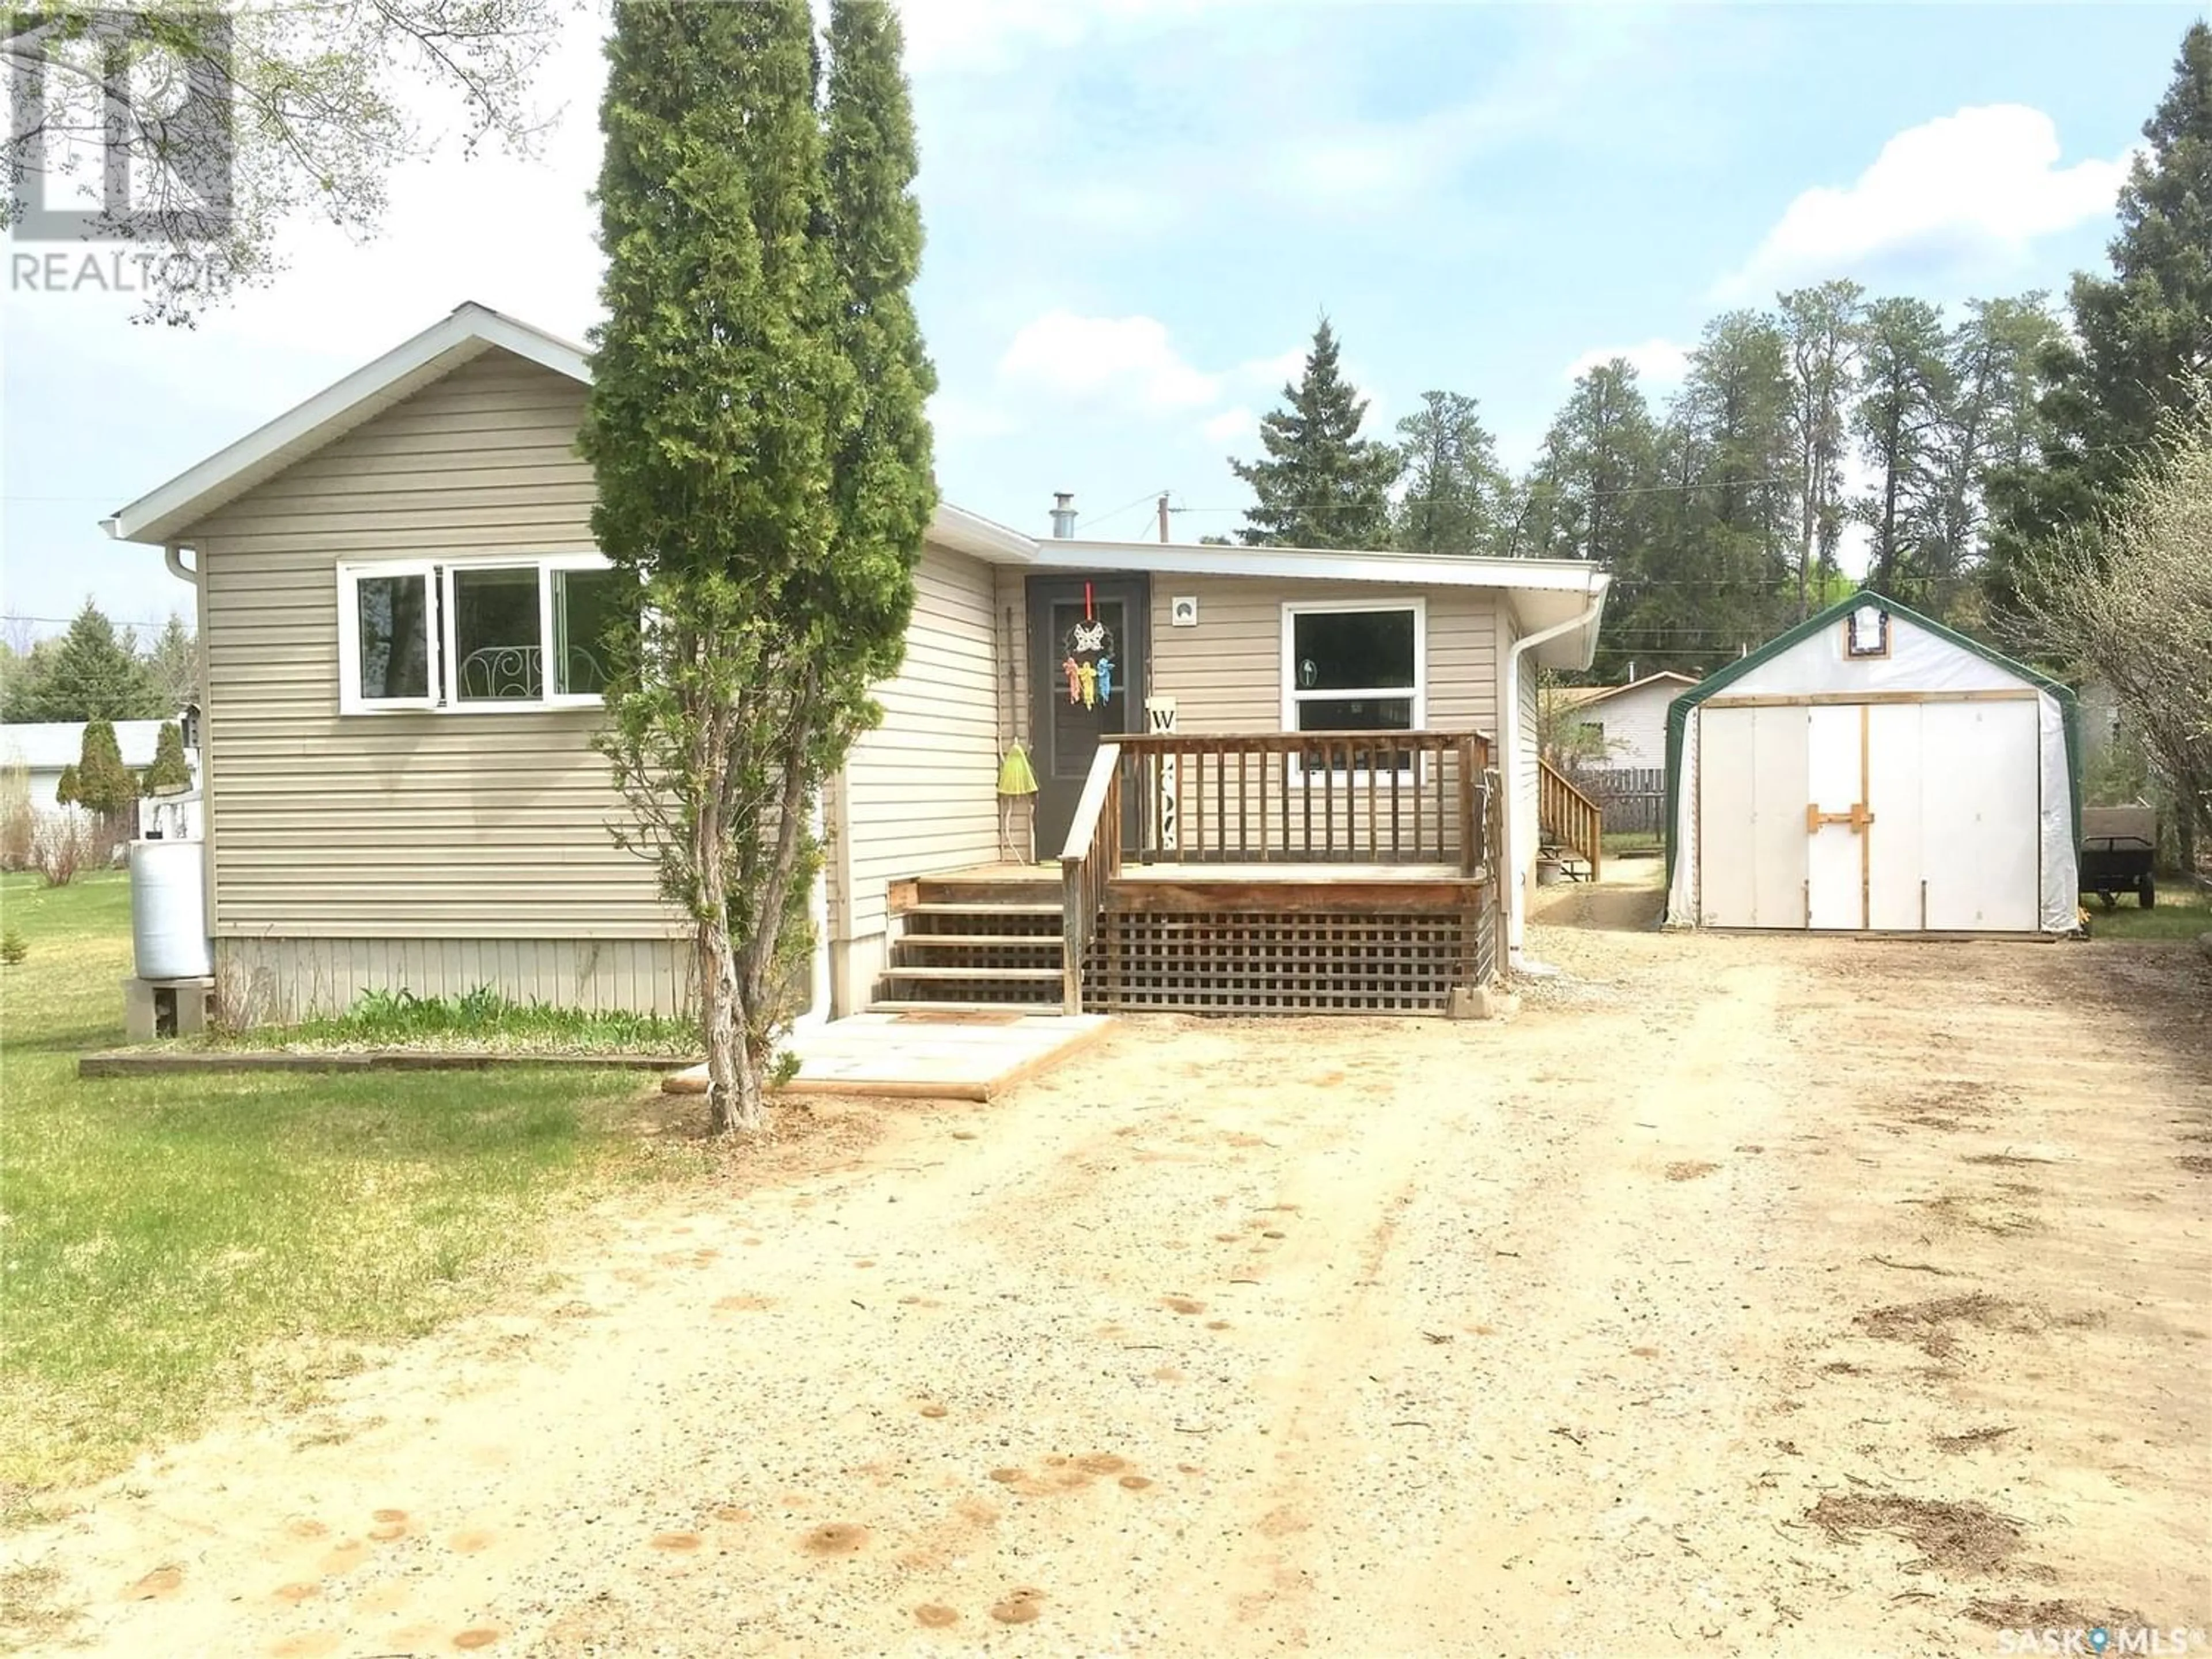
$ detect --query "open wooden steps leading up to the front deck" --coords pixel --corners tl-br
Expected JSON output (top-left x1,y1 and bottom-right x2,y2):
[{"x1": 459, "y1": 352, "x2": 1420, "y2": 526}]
[{"x1": 869, "y1": 876, "x2": 1066, "y2": 1013}]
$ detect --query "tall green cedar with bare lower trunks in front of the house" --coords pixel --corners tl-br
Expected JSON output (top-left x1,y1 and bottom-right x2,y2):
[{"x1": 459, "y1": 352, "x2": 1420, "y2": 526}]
[{"x1": 582, "y1": 0, "x2": 933, "y2": 1132}]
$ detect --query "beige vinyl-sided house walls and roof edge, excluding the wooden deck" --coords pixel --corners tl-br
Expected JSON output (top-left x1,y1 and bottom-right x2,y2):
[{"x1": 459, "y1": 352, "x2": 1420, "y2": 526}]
[{"x1": 108, "y1": 305, "x2": 1606, "y2": 1020}]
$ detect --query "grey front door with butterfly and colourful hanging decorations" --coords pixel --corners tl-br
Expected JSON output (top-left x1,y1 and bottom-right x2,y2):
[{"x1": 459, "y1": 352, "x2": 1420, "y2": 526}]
[{"x1": 1029, "y1": 575, "x2": 1150, "y2": 858}]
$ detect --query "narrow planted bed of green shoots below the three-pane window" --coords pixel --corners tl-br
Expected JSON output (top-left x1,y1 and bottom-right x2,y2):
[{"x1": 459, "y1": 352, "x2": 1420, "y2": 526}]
[{"x1": 213, "y1": 984, "x2": 699, "y2": 1055}]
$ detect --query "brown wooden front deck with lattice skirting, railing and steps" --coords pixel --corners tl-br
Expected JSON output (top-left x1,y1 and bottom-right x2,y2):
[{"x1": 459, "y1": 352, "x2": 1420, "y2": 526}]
[{"x1": 898, "y1": 732, "x2": 1502, "y2": 1013}]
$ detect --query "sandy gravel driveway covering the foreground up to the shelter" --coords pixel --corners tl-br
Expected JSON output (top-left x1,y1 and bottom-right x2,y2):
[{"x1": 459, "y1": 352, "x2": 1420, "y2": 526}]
[{"x1": 9, "y1": 896, "x2": 2212, "y2": 1654}]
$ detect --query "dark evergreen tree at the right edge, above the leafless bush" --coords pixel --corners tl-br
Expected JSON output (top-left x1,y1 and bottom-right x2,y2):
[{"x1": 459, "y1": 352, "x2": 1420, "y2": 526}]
[{"x1": 1984, "y1": 22, "x2": 2212, "y2": 608}]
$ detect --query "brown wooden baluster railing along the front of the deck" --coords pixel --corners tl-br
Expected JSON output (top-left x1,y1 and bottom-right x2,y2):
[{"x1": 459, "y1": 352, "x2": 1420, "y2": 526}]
[{"x1": 1115, "y1": 732, "x2": 1491, "y2": 876}]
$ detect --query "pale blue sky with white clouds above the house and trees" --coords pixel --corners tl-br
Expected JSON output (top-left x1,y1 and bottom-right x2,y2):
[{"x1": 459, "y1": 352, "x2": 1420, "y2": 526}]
[{"x1": 0, "y1": 0, "x2": 2205, "y2": 632}]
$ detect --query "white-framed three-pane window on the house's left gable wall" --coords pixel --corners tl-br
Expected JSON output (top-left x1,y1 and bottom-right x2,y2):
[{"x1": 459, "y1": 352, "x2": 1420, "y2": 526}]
[{"x1": 339, "y1": 553, "x2": 635, "y2": 714}]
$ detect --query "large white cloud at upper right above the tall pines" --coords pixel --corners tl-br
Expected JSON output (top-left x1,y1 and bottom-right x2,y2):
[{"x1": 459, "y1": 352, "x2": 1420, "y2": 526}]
[{"x1": 1717, "y1": 104, "x2": 2128, "y2": 298}]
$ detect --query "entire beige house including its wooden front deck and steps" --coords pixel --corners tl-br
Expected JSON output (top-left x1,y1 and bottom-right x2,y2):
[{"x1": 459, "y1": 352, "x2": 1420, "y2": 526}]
[{"x1": 106, "y1": 305, "x2": 1606, "y2": 1017}]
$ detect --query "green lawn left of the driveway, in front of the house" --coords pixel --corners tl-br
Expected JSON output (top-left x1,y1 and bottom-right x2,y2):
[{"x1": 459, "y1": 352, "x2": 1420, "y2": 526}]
[{"x1": 0, "y1": 874, "x2": 703, "y2": 1515}]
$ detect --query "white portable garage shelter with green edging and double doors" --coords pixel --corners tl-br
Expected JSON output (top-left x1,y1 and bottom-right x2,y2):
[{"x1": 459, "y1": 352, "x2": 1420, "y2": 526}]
[{"x1": 1668, "y1": 590, "x2": 2081, "y2": 933}]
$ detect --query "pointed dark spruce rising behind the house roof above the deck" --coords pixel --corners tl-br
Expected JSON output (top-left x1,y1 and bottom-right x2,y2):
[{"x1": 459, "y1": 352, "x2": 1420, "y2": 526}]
[{"x1": 1230, "y1": 316, "x2": 1404, "y2": 546}]
